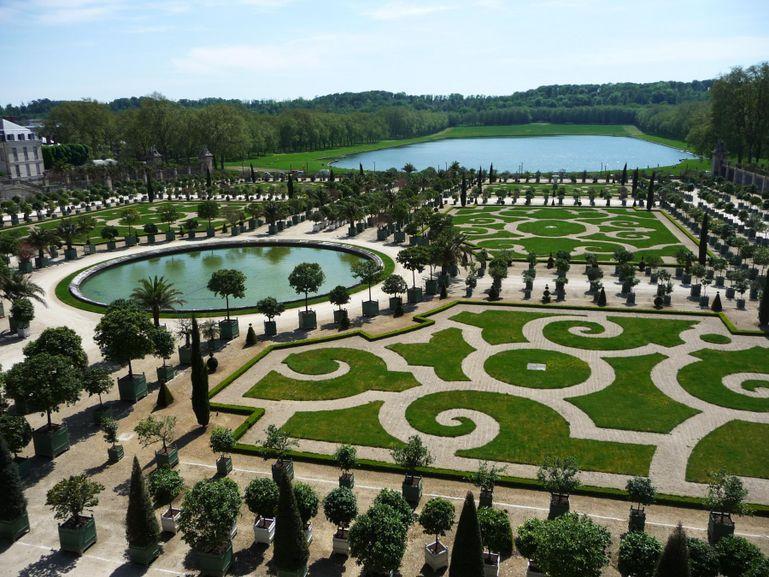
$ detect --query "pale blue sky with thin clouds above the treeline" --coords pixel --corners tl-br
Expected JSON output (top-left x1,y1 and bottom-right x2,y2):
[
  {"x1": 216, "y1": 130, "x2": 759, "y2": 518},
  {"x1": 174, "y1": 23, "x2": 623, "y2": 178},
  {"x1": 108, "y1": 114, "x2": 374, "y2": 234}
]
[{"x1": 0, "y1": 0, "x2": 769, "y2": 104}]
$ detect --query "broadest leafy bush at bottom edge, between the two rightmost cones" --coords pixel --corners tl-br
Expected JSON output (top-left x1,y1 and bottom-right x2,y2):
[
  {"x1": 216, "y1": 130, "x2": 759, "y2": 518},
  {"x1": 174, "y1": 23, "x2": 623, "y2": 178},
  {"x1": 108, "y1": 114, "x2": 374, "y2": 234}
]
[{"x1": 534, "y1": 513, "x2": 611, "y2": 577}]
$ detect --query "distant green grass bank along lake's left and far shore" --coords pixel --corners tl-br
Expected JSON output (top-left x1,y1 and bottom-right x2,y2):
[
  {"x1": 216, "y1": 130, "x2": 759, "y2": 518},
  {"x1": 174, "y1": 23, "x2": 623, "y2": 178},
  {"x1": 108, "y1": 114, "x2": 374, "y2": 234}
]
[{"x1": 227, "y1": 123, "x2": 708, "y2": 173}]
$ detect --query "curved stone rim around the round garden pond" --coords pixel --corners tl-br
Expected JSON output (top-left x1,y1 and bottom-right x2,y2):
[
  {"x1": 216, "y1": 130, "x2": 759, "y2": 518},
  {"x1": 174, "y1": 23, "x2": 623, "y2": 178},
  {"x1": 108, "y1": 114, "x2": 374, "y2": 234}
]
[{"x1": 65, "y1": 239, "x2": 384, "y2": 314}]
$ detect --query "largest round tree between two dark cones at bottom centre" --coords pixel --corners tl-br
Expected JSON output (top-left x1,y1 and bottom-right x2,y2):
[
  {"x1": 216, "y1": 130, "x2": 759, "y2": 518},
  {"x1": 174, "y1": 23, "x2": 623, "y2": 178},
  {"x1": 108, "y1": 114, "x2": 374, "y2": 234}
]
[{"x1": 349, "y1": 503, "x2": 407, "y2": 575}]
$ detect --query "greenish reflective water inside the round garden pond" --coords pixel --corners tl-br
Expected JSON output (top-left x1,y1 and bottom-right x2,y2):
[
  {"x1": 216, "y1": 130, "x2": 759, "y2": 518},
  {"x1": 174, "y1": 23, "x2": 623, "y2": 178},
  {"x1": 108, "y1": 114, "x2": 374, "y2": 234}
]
[{"x1": 80, "y1": 245, "x2": 364, "y2": 311}]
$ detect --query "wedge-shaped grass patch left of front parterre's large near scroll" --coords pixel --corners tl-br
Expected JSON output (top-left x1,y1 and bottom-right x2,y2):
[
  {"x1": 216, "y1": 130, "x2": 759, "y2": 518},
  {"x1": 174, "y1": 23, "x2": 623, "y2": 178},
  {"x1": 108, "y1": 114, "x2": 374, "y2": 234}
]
[{"x1": 283, "y1": 401, "x2": 403, "y2": 449}]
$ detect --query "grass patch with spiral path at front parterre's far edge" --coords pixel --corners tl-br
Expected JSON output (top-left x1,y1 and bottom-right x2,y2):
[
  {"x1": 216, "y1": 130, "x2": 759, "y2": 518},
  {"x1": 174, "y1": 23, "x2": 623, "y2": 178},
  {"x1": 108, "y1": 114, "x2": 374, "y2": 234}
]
[{"x1": 542, "y1": 317, "x2": 699, "y2": 351}]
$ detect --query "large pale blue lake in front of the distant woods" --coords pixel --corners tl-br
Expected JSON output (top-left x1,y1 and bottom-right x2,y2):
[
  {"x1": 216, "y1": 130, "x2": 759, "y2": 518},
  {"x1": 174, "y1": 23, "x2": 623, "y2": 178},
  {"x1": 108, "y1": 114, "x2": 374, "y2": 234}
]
[{"x1": 333, "y1": 136, "x2": 695, "y2": 172}]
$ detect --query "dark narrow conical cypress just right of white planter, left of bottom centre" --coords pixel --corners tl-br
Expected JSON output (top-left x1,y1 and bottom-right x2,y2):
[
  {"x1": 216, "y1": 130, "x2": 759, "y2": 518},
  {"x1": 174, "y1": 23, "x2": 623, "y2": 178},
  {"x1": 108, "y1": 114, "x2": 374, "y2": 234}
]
[{"x1": 273, "y1": 473, "x2": 310, "y2": 571}]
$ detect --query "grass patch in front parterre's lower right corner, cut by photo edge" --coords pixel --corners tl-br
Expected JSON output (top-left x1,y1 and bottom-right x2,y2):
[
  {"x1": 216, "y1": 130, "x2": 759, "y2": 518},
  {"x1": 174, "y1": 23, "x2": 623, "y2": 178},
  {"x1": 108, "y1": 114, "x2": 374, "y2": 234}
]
[{"x1": 686, "y1": 421, "x2": 769, "y2": 483}]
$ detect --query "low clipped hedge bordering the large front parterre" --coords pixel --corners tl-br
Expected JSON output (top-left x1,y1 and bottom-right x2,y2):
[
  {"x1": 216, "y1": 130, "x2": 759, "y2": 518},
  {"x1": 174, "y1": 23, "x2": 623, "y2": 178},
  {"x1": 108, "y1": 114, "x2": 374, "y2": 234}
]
[{"x1": 208, "y1": 299, "x2": 769, "y2": 517}]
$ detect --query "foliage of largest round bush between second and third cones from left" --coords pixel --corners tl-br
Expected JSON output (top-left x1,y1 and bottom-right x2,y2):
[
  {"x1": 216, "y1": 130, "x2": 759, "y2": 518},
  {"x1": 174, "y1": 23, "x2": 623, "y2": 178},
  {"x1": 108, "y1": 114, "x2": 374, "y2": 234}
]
[{"x1": 179, "y1": 477, "x2": 242, "y2": 554}]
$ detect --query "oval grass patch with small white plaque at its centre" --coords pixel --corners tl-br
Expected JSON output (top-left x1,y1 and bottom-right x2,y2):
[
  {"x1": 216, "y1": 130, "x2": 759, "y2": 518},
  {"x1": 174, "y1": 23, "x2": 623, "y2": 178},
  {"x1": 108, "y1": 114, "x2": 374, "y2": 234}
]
[{"x1": 483, "y1": 349, "x2": 590, "y2": 389}]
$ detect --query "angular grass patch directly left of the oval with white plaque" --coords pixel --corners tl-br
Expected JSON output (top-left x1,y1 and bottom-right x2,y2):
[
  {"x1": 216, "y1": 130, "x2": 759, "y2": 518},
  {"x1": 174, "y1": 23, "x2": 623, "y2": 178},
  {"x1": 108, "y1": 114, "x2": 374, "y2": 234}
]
[{"x1": 387, "y1": 328, "x2": 475, "y2": 381}]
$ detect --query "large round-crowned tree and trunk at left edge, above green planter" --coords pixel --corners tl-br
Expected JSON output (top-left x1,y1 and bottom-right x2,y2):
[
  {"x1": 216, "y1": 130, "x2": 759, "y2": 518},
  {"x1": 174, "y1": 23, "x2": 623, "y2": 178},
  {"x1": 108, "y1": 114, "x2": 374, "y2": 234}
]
[{"x1": 5, "y1": 353, "x2": 82, "y2": 431}]
